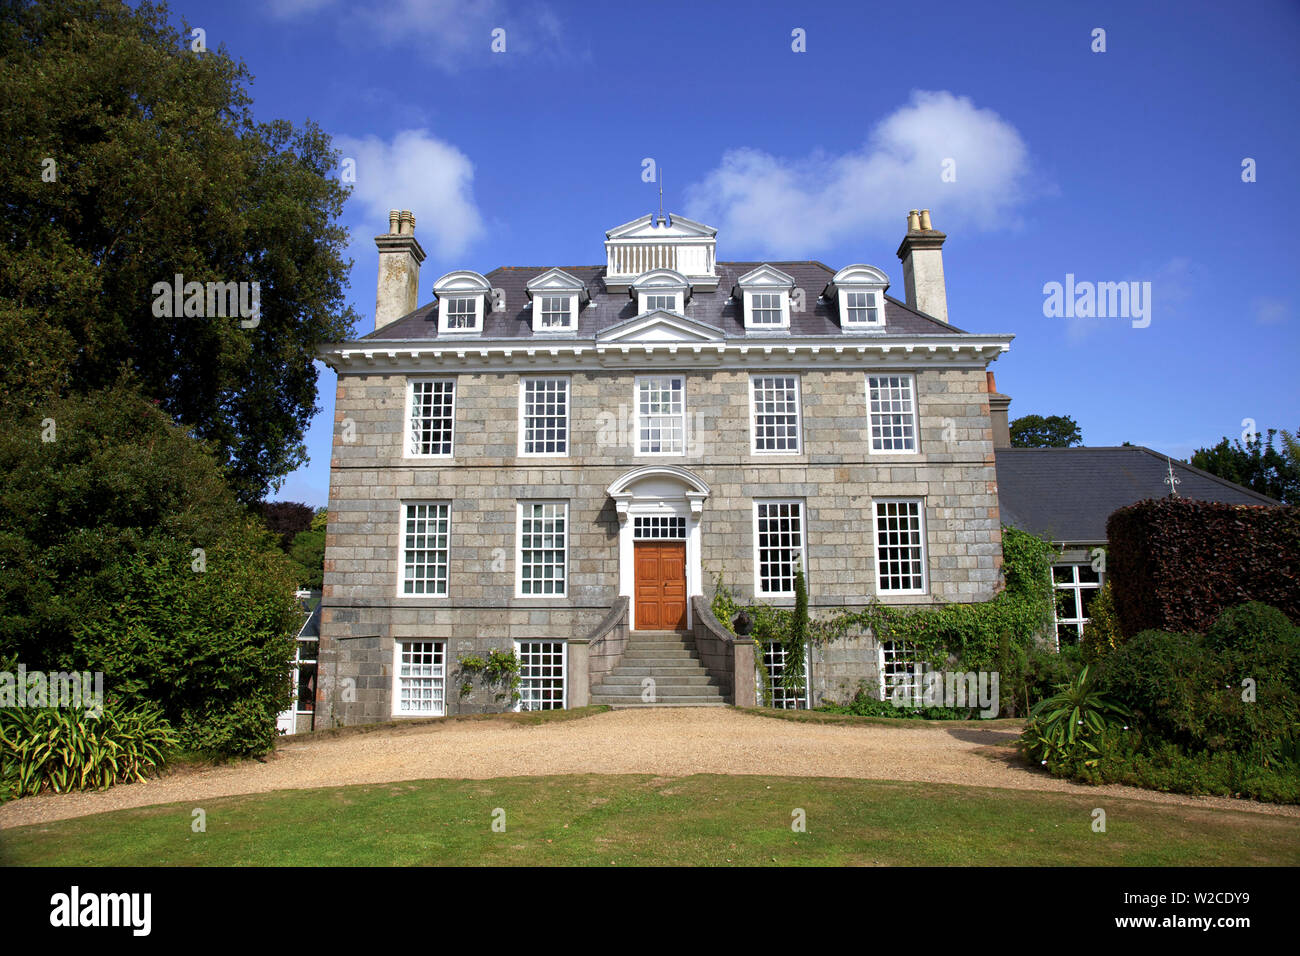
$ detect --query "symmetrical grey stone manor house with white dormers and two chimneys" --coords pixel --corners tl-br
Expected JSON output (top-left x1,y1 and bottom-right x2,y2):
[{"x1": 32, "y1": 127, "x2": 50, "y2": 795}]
[{"x1": 315, "y1": 204, "x2": 1011, "y2": 727}]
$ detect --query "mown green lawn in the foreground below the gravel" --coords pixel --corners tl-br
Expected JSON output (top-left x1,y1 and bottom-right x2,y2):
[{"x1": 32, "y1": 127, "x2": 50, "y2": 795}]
[{"x1": 0, "y1": 775, "x2": 1300, "y2": 866}]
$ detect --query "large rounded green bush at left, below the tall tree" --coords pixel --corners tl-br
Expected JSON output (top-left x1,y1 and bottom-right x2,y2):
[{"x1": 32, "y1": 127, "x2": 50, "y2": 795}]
[{"x1": 0, "y1": 378, "x2": 300, "y2": 753}]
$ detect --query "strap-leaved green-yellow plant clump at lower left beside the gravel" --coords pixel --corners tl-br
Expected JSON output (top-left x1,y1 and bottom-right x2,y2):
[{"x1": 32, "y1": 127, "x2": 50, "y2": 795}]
[{"x1": 0, "y1": 704, "x2": 177, "y2": 797}]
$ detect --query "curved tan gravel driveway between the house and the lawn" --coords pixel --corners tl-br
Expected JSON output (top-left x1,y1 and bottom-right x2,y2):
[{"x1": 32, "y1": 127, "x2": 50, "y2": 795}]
[{"x1": 0, "y1": 708, "x2": 1300, "y2": 829}]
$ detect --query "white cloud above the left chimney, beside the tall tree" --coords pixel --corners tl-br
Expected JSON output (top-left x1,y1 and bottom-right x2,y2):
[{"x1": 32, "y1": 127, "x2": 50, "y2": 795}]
[{"x1": 334, "y1": 129, "x2": 484, "y2": 259}]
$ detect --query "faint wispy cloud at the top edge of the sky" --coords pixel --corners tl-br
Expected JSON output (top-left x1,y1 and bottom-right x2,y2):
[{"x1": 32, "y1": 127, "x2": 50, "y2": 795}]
[{"x1": 269, "y1": 0, "x2": 566, "y2": 72}]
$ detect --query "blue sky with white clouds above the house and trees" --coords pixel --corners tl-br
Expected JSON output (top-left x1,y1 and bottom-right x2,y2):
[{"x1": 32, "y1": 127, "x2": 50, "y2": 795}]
[{"x1": 157, "y1": 0, "x2": 1300, "y2": 505}]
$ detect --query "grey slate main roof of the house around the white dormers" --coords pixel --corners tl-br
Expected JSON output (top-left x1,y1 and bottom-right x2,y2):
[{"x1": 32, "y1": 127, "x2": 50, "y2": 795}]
[{"x1": 361, "y1": 261, "x2": 963, "y2": 341}]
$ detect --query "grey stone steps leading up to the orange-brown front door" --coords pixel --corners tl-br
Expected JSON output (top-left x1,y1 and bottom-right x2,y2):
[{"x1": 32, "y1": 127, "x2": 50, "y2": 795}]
[{"x1": 592, "y1": 631, "x2": 727, "y2": 708}]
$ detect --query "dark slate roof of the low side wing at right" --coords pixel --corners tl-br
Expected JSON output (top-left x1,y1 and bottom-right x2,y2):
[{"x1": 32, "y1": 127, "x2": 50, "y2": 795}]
[{"x1": 995, "y1": 445, "x2": 1278, "y2": 544}]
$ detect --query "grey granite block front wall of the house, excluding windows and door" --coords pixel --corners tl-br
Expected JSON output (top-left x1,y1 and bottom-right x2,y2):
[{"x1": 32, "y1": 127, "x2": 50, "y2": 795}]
[{"x1": 316, "y1": 356, "x2": 1001, "y2": 728}]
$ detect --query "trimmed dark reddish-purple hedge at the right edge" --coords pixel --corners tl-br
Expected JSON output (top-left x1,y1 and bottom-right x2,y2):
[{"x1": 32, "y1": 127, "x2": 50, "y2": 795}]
[{"x1": 1106, "y1": 498, "x2": 1300, "y2": 637}]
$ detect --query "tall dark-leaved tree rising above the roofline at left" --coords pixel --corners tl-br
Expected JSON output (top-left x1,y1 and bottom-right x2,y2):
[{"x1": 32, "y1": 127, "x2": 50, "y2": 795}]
[{"x1": 0, "y1": 0, "x2": 356, "y2": 502}]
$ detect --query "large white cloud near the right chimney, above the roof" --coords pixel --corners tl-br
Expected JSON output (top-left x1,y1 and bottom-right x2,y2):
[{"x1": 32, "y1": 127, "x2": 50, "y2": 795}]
[{"x1": 685, "y1": 91, "x2": 1045, "y2": 255}]
